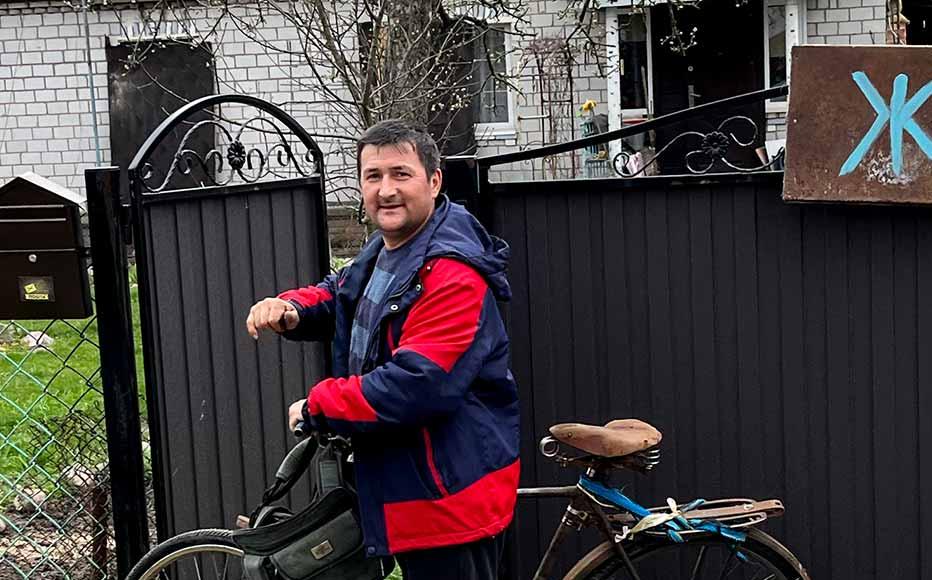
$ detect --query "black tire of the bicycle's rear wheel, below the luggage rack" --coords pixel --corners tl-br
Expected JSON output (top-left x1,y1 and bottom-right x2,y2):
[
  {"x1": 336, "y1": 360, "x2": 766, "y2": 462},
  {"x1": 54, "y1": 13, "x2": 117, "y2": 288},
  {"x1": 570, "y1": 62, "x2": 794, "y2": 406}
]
[{"x1": 564, "y1": 528, "x2": 810, "y2": 580}]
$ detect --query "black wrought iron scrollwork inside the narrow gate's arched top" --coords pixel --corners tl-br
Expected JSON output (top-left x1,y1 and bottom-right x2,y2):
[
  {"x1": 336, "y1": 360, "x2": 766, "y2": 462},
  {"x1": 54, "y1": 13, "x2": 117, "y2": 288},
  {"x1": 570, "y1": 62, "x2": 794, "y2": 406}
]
[{"x1": 140, "y1": 116, "x2": 323, "y2": 193}]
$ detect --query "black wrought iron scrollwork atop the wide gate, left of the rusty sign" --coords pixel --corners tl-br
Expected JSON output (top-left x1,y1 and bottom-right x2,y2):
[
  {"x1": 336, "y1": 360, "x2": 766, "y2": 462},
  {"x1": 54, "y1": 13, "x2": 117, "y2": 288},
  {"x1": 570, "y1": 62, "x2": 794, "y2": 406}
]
[{"x1": 612, "y1": 115, "x2": 783, "y2": 177}]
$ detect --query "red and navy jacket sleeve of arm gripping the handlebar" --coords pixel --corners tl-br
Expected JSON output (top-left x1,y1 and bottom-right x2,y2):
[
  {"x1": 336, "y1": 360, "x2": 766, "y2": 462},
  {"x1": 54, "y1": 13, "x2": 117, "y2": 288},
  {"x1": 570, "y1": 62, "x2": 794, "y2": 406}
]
[{"x1": 307, "y1": 259, "x2": 497, "y2": 434}]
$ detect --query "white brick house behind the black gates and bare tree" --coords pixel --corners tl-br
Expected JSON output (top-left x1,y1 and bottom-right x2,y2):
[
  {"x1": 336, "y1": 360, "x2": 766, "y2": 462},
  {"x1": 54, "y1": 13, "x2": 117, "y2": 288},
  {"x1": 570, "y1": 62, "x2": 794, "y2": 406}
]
[{"x1": 0, "y1": 0, "x2": 918, "y2": 197}]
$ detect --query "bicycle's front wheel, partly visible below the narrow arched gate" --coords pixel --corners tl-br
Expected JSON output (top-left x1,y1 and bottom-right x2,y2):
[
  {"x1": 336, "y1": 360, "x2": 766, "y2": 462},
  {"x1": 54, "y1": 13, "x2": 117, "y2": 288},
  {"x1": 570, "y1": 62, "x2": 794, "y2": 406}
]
[{"x1": 126, "y1": 529, "x2": 246, "y2": 580}]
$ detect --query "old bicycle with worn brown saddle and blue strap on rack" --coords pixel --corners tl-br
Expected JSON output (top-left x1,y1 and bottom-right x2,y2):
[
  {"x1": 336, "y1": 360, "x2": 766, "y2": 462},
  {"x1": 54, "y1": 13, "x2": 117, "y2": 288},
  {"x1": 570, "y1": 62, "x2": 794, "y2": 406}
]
[{"x1": 127, "y1": 419, "x2": 810, "y2": 580}]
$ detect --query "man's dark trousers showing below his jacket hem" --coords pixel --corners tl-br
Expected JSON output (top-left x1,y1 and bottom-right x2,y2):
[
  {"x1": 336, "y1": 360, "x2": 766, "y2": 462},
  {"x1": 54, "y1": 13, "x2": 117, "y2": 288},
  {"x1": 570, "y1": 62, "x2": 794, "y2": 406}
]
[{"x1": 395, "y1": 533, "x2": 505, "y2": 580}]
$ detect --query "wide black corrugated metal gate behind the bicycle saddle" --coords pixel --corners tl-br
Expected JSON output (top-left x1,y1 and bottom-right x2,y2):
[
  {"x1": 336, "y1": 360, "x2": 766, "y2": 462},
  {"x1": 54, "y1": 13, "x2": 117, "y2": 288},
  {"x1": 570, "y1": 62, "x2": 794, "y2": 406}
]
[{"x1": 478, "y1": 85, "x2": 932, "y2": 580}]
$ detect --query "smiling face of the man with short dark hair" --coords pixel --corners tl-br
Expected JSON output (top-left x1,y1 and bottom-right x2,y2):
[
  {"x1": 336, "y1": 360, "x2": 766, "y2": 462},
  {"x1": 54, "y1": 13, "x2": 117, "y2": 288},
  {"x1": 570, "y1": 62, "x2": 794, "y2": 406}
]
[{"x1": 359, "y1": 143, "x2": 441, "y2": 248}]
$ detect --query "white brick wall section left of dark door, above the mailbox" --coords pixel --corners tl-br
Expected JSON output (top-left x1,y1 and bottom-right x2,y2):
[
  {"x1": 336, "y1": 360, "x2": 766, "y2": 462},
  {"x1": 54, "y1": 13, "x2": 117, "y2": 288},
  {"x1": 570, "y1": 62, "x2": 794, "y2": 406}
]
[{"x1": 0, "y1": 2, "x2": 109, "y2": 190}]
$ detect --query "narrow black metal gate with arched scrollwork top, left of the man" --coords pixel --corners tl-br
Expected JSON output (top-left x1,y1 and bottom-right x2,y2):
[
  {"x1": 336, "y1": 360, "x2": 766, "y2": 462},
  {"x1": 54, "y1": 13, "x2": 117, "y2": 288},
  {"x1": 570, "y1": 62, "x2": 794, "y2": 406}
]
[{"x1": 129, "y1": 95, "x2": 329, "y2": 538}]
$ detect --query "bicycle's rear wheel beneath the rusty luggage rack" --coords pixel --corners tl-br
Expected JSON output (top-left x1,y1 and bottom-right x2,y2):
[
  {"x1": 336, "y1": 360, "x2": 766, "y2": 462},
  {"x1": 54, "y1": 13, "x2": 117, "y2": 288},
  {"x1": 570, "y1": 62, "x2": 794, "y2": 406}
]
[{"x1": 564, "y1": 528, "x2": 809, "y2": 580}]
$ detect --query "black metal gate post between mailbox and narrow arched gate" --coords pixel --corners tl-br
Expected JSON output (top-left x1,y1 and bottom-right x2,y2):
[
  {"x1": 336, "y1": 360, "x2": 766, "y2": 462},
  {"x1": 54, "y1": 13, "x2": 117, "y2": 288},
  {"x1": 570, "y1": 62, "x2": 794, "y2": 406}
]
[{"x1": 84, "y1": 167, "x2": 149, "y2": 578}]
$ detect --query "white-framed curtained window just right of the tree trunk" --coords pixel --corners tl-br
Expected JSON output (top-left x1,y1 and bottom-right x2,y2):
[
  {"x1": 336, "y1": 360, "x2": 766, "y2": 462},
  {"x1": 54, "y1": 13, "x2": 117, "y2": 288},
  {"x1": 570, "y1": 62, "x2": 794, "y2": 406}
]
[{"x1": 473, "y1": 25, "x2": 514, "y2": 138}]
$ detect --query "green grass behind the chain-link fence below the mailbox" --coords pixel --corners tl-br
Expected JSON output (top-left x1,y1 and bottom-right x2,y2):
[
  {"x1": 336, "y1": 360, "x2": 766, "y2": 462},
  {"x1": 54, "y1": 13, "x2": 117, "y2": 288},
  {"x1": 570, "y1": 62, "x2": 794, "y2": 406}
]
[{"x1": 0, "y1": 275, "x2": 146, "y2": 490}]
